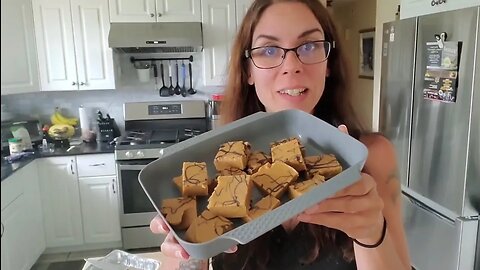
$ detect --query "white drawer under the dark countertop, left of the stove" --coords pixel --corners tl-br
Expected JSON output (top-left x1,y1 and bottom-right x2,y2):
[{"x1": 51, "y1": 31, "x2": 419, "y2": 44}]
[{"x1": 77, "y1": 154, "x2": 116, "y2": 177}]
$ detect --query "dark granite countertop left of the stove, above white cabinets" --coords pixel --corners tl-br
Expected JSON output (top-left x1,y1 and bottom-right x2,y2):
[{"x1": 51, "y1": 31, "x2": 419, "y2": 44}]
[{"x1": 1, "y1": 143, "x2": 115, "y2": 181}]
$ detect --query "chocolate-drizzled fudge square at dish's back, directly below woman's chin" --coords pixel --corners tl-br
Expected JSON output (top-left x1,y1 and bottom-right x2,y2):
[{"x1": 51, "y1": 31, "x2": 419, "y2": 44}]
[{"x1": 271, "y1": 138, "x2": 307, "y2": 172}]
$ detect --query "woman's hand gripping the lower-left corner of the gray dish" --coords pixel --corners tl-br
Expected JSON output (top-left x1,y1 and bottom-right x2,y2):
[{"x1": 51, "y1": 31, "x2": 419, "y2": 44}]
[{"x1": 150, "y1": 216, "x2": 237, "y2": 260}]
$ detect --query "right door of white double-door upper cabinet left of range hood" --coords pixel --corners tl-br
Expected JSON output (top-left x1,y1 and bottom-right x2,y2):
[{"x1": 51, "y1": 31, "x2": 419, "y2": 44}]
[{"x1": 71, "y1": 0, "x2": 115, "y2": 90}]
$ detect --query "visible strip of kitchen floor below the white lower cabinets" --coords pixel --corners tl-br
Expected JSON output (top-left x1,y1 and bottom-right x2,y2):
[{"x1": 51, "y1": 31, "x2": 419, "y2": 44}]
[{"x1": 31, "y1": 248, "x2": 160, "y2": 270}]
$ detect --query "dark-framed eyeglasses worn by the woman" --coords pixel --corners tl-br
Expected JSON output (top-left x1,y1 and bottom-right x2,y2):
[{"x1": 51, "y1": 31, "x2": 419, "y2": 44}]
[{"x1": 245, "y1": 40, "x2": 335, "y2": 69}]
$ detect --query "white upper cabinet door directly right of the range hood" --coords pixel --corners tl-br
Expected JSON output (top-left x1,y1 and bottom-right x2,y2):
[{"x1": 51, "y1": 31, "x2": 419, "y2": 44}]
[{"x1": 202, "y1": 0, "x2": 237, "y2": 86}]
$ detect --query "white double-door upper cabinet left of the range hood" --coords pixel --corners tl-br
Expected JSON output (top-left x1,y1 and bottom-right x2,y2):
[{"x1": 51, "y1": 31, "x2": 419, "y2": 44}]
[{"x1": 33, "y1": 0, "x2": 115, "y2": 91}]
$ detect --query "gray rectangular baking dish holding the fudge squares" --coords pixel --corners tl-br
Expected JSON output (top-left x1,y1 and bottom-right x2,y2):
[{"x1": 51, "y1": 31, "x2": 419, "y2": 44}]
[{"x1": 138, "y1": 110, "x2": 368, "y2": 259}]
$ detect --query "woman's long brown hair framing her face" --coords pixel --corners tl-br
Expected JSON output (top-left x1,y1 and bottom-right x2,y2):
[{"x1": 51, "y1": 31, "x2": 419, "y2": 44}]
[{"x1": 220, "y1": 0, "x2": 363, "y2": 135}]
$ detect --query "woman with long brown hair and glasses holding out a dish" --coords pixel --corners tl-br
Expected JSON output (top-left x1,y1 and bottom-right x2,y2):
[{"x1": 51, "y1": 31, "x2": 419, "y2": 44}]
[{"x1": 151, "y1": 0, "x2": 410, "y2": 270}]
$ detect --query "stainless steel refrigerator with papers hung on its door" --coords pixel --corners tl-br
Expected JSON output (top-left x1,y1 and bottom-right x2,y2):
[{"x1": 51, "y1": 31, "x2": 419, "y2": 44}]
[{"x1": 380, "y1": 7, "x2": 480, "y2": 270}]
